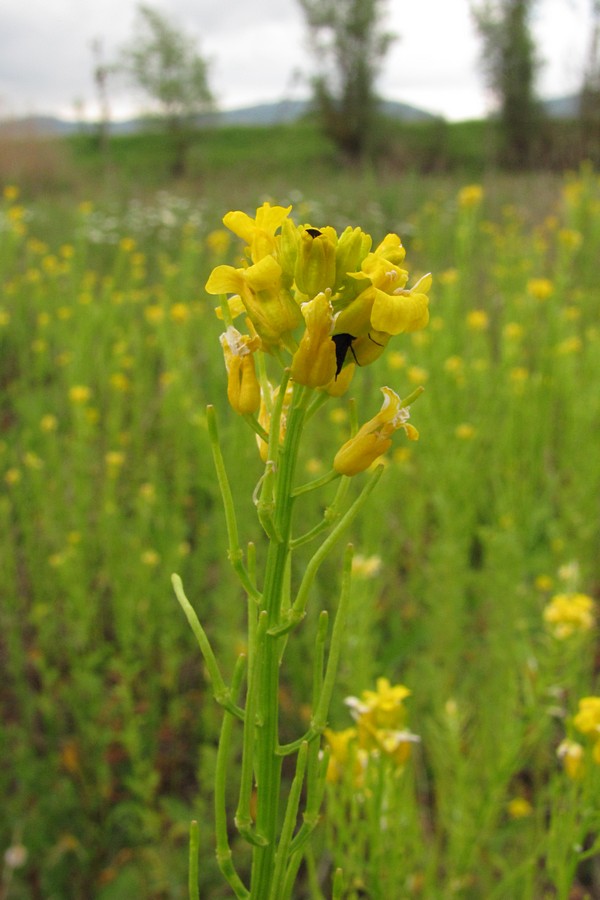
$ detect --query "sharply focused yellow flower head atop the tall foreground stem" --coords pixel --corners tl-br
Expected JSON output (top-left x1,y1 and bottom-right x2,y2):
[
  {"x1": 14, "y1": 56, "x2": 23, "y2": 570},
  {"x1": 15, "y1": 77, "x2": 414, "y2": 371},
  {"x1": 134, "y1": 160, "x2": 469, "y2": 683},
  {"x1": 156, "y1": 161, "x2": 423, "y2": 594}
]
[{"x1": 206, "y1": 203, "x2": 431, "y2": 475}]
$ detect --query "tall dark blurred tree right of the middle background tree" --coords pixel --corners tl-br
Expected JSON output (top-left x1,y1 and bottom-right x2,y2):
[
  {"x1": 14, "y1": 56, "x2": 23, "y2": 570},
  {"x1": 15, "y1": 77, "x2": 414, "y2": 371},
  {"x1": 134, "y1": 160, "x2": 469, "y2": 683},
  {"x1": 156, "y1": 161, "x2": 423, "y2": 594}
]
[{"x1": 472, "y1": 0, "x2": 542, "y2": 168}]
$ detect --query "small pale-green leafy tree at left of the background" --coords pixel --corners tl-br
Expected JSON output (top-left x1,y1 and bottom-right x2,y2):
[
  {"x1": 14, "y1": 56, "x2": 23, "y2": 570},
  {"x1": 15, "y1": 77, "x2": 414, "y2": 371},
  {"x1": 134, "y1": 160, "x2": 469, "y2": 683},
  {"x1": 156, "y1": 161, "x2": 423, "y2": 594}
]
[{"x1": 121, "y1": 4, "x2": 213, "y2": 175}]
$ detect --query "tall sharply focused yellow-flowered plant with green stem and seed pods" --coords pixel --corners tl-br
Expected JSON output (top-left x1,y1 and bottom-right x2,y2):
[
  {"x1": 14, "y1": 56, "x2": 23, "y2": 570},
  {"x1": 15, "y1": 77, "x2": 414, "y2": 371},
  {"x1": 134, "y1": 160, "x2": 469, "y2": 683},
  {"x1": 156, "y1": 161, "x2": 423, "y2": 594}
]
[{"x1": 173, "y1": 203, "x2": 431, "y2": 900}]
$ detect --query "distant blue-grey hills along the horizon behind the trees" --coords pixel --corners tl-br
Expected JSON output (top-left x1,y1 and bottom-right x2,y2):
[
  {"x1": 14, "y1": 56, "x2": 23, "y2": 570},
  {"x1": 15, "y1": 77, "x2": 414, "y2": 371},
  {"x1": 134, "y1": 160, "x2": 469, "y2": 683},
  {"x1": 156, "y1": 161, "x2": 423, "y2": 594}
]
[{"x1": 0, "y1": 94, "x2": 579, "y2": 138}]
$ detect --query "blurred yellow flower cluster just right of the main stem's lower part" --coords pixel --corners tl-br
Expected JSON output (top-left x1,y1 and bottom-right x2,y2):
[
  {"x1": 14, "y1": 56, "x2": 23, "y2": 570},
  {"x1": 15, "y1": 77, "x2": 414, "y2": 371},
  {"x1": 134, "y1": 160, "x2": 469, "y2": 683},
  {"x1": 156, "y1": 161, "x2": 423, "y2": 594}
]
[{"x1": 325, "y1": 678, "x2": 419, "y2": 784}]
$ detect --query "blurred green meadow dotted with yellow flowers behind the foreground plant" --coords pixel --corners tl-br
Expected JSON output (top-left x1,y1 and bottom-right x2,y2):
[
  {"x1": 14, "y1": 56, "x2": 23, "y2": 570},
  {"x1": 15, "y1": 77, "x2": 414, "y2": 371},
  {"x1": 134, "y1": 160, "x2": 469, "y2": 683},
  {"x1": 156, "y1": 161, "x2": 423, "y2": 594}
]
[{"x1": 0, "y1": 123, "x2": 600, "y2": 900}]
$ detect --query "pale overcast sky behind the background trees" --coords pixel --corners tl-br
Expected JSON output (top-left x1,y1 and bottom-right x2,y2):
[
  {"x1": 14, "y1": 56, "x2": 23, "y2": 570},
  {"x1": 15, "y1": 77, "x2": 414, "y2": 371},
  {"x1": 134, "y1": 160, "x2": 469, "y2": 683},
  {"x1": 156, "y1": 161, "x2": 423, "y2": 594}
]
[{"x1": 0, "y1": 0, "x2": 591, "y2": 120}]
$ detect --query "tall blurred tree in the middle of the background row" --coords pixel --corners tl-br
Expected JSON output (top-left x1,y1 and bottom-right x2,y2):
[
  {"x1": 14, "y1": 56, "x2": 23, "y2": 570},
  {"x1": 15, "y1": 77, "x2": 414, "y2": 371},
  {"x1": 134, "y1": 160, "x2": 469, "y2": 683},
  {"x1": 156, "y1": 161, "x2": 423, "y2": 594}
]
[{"x1": 298, "y1": 0, "x2": 394, "y2": 160}]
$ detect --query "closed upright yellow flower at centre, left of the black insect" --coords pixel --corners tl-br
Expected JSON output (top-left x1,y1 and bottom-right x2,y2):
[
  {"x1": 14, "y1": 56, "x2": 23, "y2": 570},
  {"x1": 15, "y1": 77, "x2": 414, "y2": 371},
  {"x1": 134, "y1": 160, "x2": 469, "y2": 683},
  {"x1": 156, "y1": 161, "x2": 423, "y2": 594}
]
[{"x1": 292, "y1": 293, "x2": 337, "y2": 387}]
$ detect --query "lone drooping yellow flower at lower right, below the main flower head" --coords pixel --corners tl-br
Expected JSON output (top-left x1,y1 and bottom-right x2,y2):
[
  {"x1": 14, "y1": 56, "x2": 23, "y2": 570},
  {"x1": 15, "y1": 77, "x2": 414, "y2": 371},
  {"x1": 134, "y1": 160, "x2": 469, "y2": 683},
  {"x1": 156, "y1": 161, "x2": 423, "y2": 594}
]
[{"x1": 333, "y1": 387, "x2": 419, "y2": 475}]
